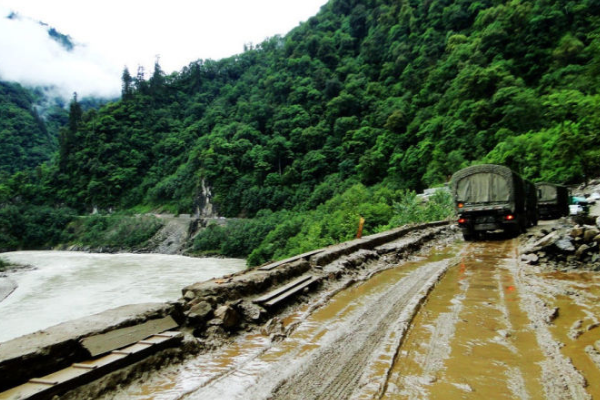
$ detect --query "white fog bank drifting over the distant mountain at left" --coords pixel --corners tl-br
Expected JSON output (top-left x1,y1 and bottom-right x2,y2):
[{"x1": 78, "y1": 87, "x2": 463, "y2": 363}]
[{"x1": 0, "y1": 8, "x2": 122, "y2": 99}]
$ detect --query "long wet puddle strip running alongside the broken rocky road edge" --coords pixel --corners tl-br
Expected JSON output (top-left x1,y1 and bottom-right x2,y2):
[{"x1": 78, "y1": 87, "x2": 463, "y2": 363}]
[{"x1": 106, "y1": 245, "x2": 460, "y2": 400}]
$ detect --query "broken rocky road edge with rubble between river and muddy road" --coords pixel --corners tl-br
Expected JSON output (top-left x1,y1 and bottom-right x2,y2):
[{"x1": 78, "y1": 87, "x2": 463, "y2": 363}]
[{"x1": 0, "y1": 222, "x2": 455, "y2": 398}]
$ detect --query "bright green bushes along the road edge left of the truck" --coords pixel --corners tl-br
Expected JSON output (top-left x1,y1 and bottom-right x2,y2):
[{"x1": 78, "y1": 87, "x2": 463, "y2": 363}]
[{"x1": 189, "y1": 184, "x2": 454, "y2": 266}]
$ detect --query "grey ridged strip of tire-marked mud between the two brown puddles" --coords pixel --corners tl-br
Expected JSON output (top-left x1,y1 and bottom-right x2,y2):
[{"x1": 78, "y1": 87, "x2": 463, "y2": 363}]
[{"x1": 269, "y1": 260, "x2": 458, "y2": 400}]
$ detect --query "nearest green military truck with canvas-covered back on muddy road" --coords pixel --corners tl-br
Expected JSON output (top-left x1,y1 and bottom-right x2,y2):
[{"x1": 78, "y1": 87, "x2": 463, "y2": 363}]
[{"x1": 450, "y1": 164, "x2": 538, "y2": 240}]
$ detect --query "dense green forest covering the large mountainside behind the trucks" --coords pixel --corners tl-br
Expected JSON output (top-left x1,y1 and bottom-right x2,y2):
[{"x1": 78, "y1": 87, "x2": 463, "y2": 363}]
[{"x1": 0, "y1": 0, "x2": 600, "y2": 262}]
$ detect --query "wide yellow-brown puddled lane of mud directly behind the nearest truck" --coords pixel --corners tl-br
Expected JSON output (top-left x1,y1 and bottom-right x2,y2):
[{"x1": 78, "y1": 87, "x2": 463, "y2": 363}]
[{"x1": 381, "y1": 240, "x2": 546, "y2": 399}]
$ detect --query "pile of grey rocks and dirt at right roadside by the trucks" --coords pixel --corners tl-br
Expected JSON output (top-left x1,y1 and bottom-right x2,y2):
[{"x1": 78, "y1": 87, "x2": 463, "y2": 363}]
[{"x1": 520, "y1": 218, "x2": 600, "y2": 271}]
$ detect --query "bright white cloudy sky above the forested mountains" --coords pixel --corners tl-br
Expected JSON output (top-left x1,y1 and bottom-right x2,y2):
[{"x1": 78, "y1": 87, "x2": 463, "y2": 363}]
[{"x1": 0, "y1": 0, "x2": 327, "y2": 99}]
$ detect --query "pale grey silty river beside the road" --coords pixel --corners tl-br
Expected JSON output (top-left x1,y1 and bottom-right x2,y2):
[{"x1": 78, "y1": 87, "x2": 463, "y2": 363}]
[{"x1": 0, "y1": 251, "x2": 245, "y2": 342}]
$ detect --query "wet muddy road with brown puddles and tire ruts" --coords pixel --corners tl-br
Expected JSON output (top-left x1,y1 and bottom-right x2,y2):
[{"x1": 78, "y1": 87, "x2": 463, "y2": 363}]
[{"x1": 104, "y1": 238, "x2": 600, "y2": 400}]
